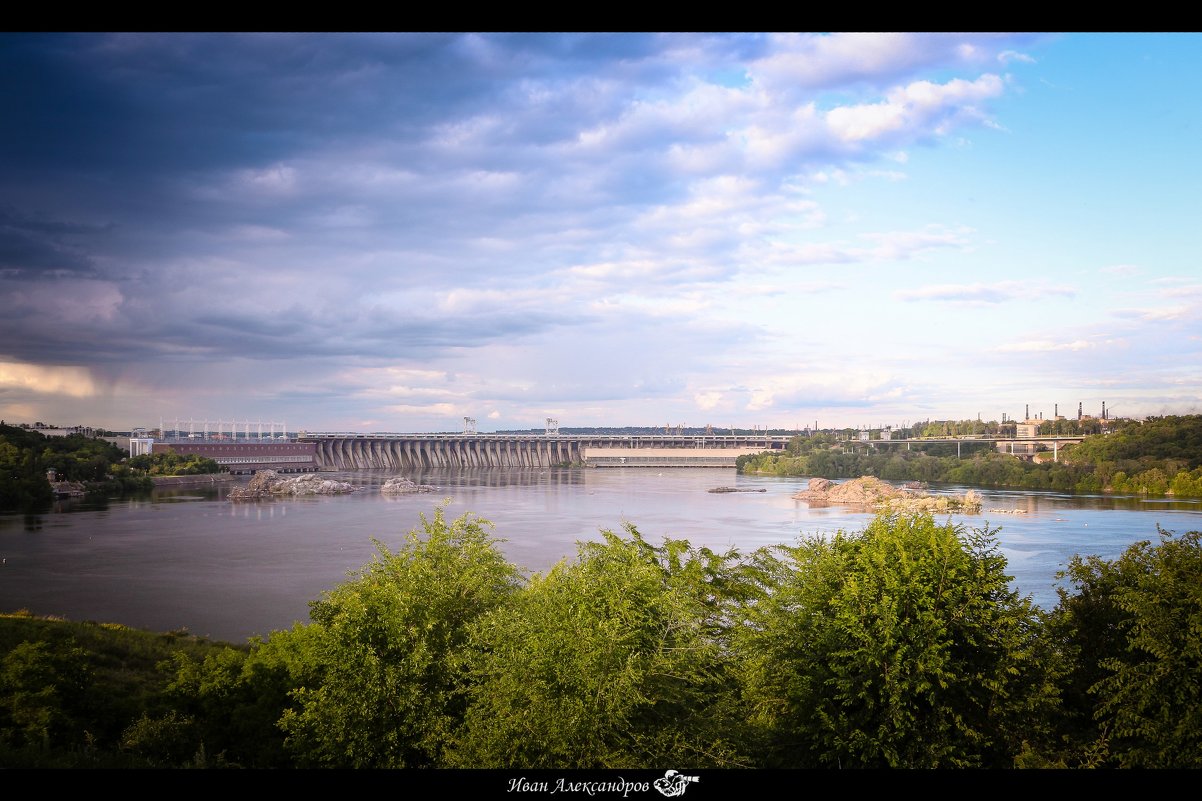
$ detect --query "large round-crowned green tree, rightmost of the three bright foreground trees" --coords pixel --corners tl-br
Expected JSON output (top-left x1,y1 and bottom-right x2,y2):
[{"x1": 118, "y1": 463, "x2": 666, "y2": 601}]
[{"x1": 742, "y1": 515, "x2": 1055, "y2": 767}]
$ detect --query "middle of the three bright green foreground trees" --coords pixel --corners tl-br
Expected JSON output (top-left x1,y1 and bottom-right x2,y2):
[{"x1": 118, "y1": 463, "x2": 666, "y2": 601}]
[{"x1": 452, "y1": 526, "x2": 758, "y2": 769}]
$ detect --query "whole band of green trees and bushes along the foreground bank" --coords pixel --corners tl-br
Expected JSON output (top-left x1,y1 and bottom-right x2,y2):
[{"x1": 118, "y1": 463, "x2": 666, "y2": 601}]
[{"x1": 0, "y1": 508, "x2": 1202, "y2": 769}]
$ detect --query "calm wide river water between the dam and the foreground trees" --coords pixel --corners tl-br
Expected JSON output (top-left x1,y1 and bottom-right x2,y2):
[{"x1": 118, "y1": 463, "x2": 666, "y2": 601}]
[{"x1": 0, "y1": 468, "x2": 1202, "y2": 642}]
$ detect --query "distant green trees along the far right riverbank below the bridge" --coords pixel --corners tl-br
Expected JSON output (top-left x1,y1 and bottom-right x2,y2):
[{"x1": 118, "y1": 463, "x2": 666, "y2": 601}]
[{"x1": 738, "y1": 415, "x2": 1202, "y2": 498}]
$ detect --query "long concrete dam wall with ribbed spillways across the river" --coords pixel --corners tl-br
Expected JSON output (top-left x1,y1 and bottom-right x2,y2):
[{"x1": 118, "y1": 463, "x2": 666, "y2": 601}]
[{"x1": 296, "y1": 432, "x2": 790, "y2": 470}]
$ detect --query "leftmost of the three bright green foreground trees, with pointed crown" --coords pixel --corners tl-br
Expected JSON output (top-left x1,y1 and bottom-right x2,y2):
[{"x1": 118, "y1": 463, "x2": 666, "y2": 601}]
[{"x1": 275, "y1": 506, "x2": 522, "y2": 767}]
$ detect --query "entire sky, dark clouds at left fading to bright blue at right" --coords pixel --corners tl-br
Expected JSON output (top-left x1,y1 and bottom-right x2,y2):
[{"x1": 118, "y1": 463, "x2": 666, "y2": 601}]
[{"x1": 0, "y1": 34, "x2": 1202, "y2": 432}]
